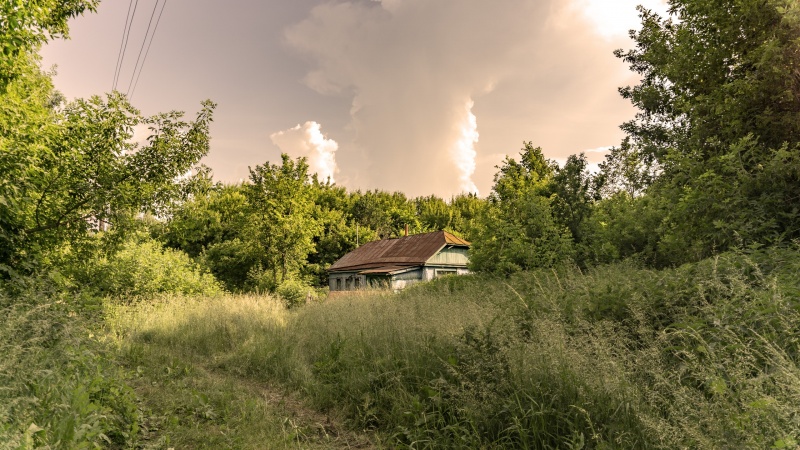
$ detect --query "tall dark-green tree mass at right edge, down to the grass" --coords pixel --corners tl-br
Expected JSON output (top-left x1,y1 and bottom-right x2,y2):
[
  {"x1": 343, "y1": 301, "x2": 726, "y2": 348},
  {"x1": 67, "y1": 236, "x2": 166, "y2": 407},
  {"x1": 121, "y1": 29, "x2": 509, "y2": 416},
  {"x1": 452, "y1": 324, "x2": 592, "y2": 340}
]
[{"x1": 616, "y1": 0, "x2": 800, "y2": 264}]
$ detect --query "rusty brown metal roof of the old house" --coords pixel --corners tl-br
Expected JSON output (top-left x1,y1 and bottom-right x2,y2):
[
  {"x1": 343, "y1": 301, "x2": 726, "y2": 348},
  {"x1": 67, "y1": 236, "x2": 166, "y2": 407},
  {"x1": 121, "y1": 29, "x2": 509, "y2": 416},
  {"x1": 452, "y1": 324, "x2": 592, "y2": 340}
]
[{"x1": 328, "y1": 231, "x2": 470, "y2": 272}]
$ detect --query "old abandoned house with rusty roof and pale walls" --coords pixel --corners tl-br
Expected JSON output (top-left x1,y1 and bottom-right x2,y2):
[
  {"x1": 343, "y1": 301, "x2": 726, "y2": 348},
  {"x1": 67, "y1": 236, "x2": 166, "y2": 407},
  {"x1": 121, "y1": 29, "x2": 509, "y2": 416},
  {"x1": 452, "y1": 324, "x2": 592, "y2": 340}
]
[{"x1": 328, "y1": 231, "x2": 470, "y2": 291}]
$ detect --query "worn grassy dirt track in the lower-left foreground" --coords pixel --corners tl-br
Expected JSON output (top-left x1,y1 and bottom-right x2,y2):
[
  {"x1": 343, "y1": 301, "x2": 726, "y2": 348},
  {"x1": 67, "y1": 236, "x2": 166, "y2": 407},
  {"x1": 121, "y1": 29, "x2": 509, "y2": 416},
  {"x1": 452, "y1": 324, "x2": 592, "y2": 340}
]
[{"x1": 129, "y1": 355, "x2": 386, "y2": 450}]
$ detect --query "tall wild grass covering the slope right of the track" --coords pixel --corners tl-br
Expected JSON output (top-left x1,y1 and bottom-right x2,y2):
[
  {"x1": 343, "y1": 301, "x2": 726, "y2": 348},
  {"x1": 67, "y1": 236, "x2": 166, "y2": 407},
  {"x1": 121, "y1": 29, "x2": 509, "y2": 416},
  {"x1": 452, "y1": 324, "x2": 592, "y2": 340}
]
[{"x1": 109, "y1": 250, "x2": 800, "y2": 449}]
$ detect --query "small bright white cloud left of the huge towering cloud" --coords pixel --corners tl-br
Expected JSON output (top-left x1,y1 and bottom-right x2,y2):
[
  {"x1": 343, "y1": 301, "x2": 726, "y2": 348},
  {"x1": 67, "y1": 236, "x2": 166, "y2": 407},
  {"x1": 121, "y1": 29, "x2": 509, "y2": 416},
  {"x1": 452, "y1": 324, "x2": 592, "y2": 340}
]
[{"x1": 269, "y1": 121, "x2": 339, "y2": 182}]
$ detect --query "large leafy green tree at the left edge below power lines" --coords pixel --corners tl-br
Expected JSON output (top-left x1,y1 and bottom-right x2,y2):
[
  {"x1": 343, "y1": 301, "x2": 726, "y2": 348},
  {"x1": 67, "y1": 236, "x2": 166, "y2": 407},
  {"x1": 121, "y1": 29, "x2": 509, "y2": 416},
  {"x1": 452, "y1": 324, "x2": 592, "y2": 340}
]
[{"x1": 0, "y1": 0, "x2": 214, "y2": 273}]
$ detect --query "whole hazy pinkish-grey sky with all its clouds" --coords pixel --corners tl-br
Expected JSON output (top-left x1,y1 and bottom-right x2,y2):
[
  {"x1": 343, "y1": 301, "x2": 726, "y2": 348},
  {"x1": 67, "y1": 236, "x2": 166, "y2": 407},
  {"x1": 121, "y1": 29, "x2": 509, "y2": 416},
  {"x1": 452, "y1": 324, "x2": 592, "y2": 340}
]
[{"x1": 42, "y1": 0, "x2": 666, "y2": 198}]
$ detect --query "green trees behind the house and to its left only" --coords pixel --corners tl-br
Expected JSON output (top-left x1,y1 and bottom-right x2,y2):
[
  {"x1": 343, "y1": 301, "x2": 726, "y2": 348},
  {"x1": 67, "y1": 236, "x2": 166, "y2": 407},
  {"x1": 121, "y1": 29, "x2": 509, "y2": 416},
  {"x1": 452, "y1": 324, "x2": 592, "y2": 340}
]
[{"x1": 150, "y1": 159, "x2": 486, "y2": 292}]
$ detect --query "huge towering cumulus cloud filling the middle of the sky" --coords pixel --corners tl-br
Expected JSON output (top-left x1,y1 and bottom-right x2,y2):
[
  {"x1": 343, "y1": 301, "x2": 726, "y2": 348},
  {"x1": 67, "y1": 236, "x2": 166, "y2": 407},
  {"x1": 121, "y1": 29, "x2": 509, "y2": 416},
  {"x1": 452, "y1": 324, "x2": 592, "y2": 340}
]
[{"x1": 284, "y1": 0, "x2": 660, "y2": 197}]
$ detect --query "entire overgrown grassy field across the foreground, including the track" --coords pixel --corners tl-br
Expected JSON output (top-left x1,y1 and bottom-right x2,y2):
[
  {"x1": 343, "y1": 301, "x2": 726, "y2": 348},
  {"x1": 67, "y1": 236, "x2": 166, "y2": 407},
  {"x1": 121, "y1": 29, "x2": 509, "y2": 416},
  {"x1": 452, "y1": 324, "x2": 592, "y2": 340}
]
[{"x1": 0, "y1": 250, "x2": 800, "y2": 449}]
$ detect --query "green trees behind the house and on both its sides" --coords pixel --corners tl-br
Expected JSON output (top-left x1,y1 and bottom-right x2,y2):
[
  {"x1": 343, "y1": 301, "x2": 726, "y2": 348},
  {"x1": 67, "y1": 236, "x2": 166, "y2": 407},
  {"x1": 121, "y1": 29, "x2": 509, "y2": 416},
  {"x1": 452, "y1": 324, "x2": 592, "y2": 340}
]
[{"x1": 149, "y1": 143, "x2": 604, "y2": 292}]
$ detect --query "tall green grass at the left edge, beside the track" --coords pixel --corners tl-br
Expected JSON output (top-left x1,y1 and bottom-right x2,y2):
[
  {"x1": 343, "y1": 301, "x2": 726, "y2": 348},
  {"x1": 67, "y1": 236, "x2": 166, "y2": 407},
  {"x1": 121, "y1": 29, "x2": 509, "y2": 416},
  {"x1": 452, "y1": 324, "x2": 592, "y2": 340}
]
[{"x1": 0, "y1": 280, "x2": 141, "y2": 449}]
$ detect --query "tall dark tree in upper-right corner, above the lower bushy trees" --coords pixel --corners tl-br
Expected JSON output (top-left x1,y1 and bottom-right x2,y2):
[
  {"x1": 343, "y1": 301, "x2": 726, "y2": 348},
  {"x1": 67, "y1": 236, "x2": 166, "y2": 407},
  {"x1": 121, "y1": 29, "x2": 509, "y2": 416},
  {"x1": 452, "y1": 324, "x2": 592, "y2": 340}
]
[{"x1": 616, "y1": 0, "x2": 800, "y2": 167}]
